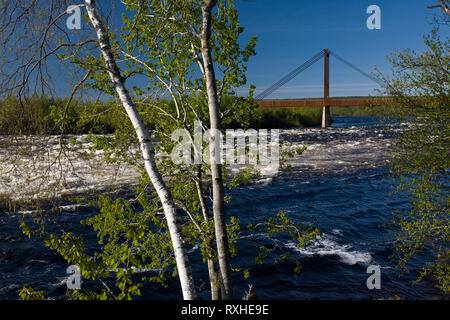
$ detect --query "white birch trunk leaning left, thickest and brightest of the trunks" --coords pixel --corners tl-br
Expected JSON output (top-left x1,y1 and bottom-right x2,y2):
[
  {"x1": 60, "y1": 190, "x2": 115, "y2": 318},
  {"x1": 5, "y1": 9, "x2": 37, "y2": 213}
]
[{"x1": 84, "y1": 0, "x2": 196, "y2": 300}]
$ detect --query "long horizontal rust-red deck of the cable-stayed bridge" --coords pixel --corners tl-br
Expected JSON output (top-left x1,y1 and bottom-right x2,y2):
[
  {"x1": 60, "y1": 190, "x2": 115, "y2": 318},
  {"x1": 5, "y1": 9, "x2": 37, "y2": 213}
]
[{"x1": 255, "y1": 99, "x2": 387, "y2": 108}]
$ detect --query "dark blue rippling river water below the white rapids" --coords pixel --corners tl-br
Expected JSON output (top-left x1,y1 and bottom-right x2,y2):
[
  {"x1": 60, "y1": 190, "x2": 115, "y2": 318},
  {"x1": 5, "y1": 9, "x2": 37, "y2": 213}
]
[{"x1": 0, "y1": 117, "x2": 440, "y2": 299}]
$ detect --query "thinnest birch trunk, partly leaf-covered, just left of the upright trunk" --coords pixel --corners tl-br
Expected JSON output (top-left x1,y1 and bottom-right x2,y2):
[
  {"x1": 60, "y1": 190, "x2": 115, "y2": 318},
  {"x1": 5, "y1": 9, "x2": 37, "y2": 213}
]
[{"x1": 195, "y1": 167, "x2": 221, "y2": 300}]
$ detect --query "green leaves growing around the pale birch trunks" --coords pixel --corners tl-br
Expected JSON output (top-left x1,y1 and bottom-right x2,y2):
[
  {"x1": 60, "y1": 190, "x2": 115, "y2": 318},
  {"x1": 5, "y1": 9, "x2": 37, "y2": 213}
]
[{"x1": 18, "y1": 0, "x2": 317, "y2": 299}]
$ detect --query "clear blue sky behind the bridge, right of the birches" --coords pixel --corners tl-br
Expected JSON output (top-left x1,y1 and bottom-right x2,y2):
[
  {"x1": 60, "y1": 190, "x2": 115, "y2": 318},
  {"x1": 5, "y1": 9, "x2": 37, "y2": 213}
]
[{"x1": 237, "y1": 0, "x2": 448, "y2": 98}]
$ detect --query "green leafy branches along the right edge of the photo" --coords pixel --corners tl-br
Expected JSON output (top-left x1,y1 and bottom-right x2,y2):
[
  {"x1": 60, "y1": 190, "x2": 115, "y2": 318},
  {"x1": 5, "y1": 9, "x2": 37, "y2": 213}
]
[{"x1": 383, "y1": 28, "x2": 450, "y2": 293}]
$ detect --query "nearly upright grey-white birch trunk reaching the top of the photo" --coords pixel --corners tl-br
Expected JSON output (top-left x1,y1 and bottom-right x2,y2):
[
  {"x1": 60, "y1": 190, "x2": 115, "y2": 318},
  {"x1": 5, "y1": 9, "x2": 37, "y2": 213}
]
[{"x1": 200, "y1": 0, "x2": 233, "y2": 299}]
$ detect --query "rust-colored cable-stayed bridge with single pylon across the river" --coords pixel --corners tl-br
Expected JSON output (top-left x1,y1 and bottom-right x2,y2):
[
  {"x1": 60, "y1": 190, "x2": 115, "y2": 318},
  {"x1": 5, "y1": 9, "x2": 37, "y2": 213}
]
[{"x1": 255, "y1": 49, "x2": 386, "y2": 128}]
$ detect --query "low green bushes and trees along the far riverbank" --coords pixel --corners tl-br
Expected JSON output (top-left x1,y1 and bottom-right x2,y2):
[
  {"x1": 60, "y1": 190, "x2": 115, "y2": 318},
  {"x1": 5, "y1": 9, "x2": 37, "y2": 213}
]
[{"x1": 0, "y1": 96, "x2": 392, "y2": 135}]
